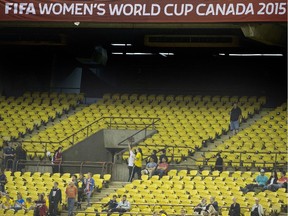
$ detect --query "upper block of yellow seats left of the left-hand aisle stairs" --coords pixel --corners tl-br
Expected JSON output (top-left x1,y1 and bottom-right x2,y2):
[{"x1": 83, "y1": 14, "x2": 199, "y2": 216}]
[{"x1": 0, "y1": 91, "x2": 80, "y2": 147}]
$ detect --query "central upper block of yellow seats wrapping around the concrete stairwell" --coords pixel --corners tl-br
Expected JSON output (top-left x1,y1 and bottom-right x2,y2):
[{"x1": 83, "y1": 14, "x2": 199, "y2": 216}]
[{"x1": 26, "y1": 93, "x2": 262, "y2": 161}]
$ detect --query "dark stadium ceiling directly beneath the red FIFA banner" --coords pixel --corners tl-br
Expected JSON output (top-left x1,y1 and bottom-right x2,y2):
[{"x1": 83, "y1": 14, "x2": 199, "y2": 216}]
[{"x1": 0, "y1": 22, "x2": 287, "y2": 55}]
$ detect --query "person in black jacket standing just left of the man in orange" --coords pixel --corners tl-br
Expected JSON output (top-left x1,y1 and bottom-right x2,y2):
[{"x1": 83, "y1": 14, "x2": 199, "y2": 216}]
[{"x1": 49, "y1": 182, "x2": 62, "y2": 216}]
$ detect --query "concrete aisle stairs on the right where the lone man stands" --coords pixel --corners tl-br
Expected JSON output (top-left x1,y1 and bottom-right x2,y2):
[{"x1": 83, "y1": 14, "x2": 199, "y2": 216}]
[{"x1": 180, "y1": 108, "x2": 272, "y2": 169}]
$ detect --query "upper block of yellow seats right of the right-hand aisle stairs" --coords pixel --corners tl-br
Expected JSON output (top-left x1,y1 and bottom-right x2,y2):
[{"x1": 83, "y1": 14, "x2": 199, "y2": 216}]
[{"x1": 213, "y1": 104, "x2": 287, "y2": 167}]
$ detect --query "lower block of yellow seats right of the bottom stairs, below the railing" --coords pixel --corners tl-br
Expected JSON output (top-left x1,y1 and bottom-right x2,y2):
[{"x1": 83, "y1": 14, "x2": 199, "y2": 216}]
[{"x1": 93, "y1": 170, "x2": 287, "y2": 214}]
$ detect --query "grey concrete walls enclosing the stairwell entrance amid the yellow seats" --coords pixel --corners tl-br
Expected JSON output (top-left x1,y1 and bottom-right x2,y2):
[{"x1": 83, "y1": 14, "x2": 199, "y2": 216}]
[{"x1": 63, "y1": 129, "x2": 156, "y2": 181}]
